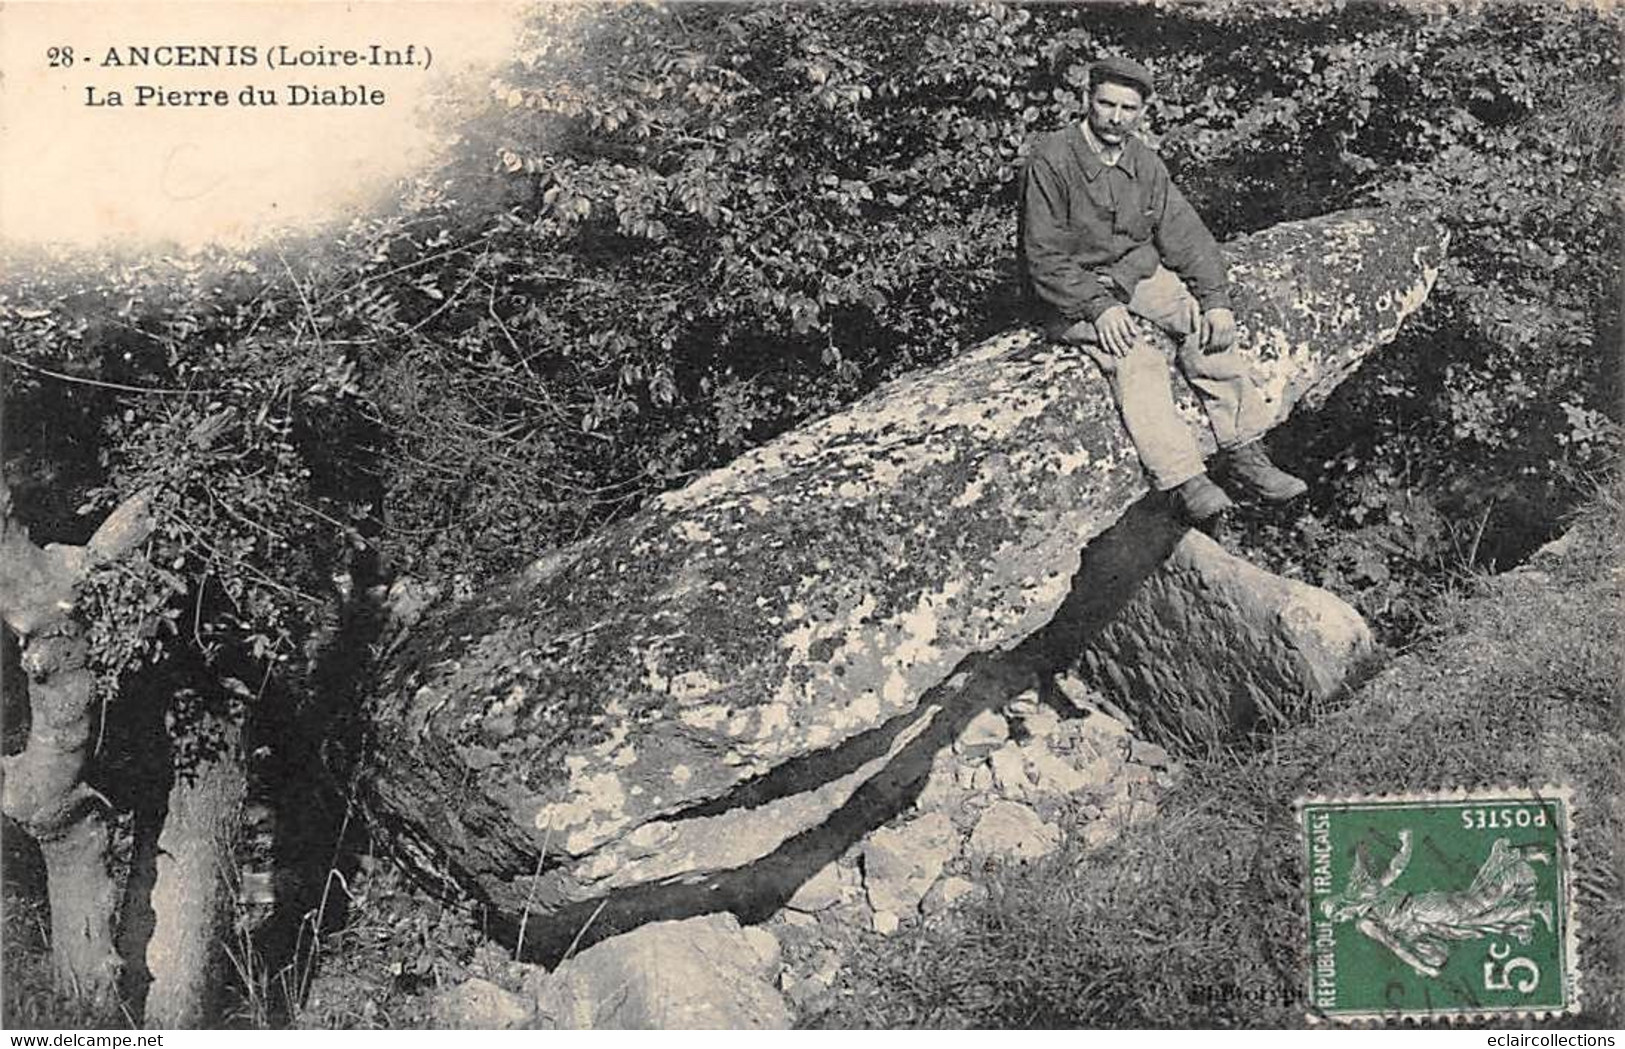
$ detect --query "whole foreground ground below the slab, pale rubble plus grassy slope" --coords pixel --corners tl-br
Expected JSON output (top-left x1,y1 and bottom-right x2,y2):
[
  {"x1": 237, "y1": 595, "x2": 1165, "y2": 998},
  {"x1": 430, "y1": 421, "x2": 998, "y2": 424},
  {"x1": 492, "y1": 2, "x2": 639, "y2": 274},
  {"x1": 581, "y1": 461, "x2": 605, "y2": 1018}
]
[{"x1": 273, "y1": 497, "x2": 1625, "y2": 1028}]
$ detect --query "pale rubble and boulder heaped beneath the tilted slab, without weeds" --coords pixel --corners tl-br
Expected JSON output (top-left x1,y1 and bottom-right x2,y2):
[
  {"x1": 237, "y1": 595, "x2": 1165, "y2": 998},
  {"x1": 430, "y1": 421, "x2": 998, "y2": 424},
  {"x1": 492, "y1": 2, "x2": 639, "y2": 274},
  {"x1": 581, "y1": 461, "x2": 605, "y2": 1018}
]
[{"x1": 431, "y1": 679, "x2": 1180, "y2": 1030}]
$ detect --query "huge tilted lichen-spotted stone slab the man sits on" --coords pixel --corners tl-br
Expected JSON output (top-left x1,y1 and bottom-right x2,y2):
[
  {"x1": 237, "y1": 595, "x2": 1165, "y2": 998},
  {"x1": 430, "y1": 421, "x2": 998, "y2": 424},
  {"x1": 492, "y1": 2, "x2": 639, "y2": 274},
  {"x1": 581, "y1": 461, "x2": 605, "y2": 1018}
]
[{"x1": 372, "y1": 211, "x2": 1445, "y2": 937}]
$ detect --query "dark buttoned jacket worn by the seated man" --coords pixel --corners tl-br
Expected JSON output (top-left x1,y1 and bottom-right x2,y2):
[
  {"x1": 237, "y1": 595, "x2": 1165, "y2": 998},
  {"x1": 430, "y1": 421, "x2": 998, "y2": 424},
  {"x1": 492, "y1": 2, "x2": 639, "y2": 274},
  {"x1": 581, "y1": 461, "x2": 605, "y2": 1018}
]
[{"x1": 1019, "y1": 125, "x2": 1230, "y2": 330}]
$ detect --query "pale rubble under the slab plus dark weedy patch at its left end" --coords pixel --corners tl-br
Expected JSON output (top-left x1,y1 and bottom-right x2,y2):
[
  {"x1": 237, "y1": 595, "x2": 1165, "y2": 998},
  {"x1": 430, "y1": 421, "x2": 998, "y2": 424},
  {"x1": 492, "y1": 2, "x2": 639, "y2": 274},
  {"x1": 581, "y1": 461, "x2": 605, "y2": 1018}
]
[{"x1": 297, "y1": 679, "x2": 1181, "y2": 1028}]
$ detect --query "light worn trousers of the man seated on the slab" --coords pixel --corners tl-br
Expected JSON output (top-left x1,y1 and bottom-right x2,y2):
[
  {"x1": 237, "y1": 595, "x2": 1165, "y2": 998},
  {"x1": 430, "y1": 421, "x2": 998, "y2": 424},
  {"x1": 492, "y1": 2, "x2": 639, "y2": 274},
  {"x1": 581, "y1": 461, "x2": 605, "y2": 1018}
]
[{"x1": 1056, "y1": 266, "x2": 1274, "y2": 490}]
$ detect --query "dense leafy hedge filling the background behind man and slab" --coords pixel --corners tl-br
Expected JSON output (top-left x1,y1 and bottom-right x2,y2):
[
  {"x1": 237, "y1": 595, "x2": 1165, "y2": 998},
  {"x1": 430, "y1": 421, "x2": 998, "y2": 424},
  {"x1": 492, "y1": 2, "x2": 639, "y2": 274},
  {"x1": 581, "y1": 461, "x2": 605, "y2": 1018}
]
[{"x1": 0, "y1": 0, "x2": 1625, "y2": 1032}]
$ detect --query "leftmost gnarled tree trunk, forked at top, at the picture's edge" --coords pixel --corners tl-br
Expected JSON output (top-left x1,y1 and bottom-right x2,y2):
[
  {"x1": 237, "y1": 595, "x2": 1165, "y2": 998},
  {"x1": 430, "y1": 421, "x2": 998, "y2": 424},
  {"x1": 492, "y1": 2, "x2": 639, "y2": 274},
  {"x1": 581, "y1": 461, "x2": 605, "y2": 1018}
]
[{"x1": 0, "y1": 479, "x2": 151, "y2": 1010}]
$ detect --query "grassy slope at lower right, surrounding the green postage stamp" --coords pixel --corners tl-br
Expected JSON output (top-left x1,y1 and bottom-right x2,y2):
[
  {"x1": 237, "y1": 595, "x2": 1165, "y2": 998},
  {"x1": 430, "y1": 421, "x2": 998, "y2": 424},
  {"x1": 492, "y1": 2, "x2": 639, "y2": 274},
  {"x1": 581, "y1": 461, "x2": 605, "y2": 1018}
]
[{"x1": 813, "y1": 477, "x2": 1625, "y2": 1028}]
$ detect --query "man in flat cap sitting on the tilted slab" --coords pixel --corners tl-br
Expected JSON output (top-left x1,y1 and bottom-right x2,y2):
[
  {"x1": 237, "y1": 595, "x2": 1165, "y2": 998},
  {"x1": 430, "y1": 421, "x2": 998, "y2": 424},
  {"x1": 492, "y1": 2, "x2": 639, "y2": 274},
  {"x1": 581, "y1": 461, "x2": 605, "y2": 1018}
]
[{"x1": 1021, "y1": 58, "x2": 1307, "y2": 523}]
